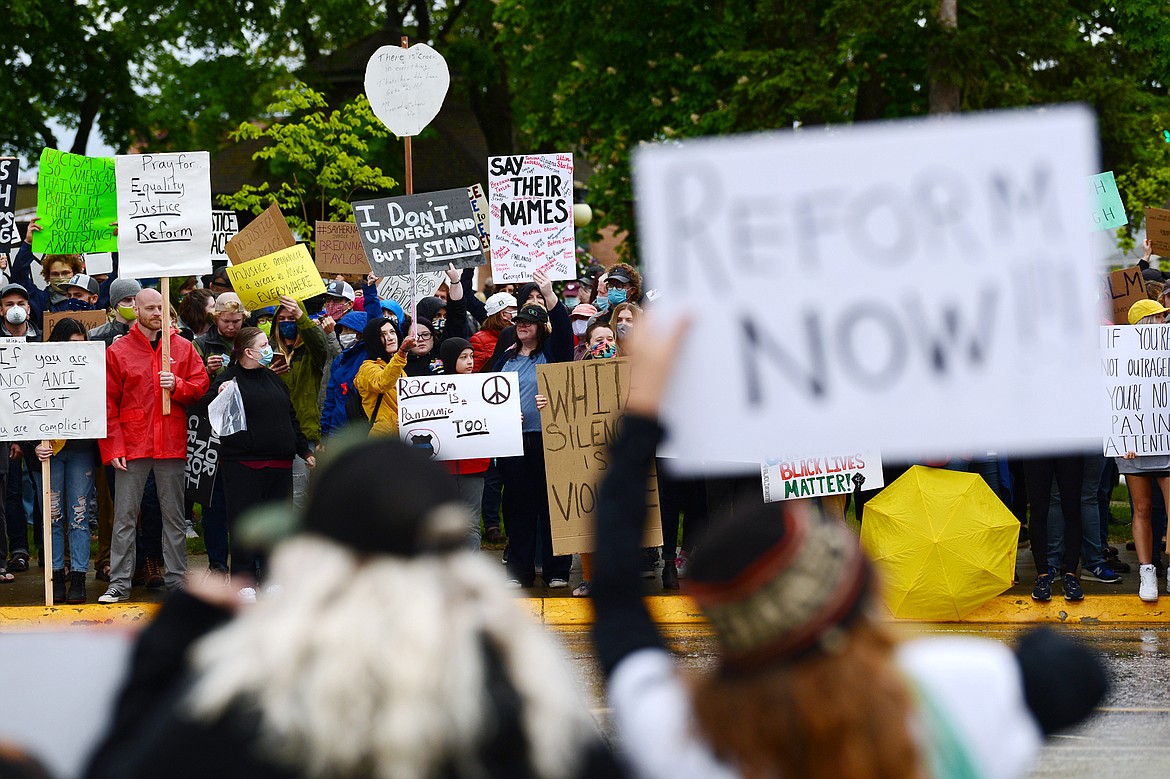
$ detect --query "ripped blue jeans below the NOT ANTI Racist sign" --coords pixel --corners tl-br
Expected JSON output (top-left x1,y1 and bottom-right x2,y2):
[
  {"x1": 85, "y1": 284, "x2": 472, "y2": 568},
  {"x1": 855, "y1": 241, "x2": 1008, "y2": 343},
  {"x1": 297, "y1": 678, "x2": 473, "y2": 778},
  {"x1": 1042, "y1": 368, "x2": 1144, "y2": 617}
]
[{"x1": 30, "y1": 441, "x2": 97, "y2": 571}]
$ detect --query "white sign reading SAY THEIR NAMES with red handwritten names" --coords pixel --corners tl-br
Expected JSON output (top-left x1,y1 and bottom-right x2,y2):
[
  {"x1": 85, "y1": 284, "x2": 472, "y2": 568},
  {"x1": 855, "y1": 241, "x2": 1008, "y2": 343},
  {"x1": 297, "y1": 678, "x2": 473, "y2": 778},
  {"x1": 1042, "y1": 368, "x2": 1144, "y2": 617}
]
[{"x1": 488, "y1": 153, "x2": 577, "y2": 284}]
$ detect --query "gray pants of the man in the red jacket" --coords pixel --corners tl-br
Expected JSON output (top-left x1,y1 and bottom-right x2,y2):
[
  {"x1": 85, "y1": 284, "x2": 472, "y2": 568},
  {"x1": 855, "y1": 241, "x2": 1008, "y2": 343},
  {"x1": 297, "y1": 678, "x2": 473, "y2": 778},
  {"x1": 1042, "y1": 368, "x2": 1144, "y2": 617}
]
[{"x1": 110, "y1": 459, "x2": 187, "y2": 592}]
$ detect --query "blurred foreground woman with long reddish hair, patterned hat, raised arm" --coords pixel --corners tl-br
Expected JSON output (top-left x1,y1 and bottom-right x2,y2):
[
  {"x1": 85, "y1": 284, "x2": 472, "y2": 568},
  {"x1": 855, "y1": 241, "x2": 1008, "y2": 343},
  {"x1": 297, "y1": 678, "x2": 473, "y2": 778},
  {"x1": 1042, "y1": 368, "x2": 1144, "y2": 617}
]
[{"x1": 592, "y1": 315, "x2": 1108, "y2": 779}]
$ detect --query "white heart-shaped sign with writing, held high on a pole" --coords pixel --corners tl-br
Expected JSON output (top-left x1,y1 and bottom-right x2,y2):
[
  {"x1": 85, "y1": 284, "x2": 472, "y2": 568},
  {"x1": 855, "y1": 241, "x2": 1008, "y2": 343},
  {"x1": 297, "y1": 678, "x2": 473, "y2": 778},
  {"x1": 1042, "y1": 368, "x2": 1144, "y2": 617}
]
[{"x1": 365, "y1": 43, "x2": 450, "y2": 137}]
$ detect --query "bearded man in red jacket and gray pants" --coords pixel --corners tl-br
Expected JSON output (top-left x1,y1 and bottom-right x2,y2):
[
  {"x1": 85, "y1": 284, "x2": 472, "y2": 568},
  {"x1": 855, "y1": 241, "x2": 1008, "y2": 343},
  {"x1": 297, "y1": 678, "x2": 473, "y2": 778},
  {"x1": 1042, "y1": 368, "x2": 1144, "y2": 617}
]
[{"x1": 97, "y1": 289, "x2": 208, "y2": 604}]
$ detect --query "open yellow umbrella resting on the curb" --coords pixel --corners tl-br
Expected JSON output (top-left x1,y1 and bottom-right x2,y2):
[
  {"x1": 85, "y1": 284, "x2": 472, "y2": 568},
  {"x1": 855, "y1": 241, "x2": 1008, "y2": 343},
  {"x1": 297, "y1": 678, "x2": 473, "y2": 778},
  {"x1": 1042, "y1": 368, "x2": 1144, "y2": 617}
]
[{"x1": 861, "y1": 466, "x2": 1020, "y2": 620}]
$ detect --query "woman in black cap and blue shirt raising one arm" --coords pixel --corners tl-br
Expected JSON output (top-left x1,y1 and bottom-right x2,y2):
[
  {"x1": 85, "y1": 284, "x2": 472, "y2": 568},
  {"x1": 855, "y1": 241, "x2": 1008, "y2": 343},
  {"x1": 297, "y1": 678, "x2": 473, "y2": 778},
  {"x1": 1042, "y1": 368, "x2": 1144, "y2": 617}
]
[{"x1": 493, "y1": 270, "x2": 573, "y2": 590}]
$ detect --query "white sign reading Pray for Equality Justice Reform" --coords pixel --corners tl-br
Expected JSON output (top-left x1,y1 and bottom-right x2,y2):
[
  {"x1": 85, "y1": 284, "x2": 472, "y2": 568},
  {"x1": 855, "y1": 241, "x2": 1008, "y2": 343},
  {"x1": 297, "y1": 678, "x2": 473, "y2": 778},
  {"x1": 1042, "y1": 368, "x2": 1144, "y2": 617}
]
[{"x1": 115, "y1": 152, "x2": 213, "y2": 278}]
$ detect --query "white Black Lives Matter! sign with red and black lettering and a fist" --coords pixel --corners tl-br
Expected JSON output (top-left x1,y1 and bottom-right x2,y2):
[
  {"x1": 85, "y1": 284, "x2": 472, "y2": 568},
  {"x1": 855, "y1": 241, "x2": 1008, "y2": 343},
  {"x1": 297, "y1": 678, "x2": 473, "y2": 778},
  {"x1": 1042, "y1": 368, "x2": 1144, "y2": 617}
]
[{"x1": 759, "y1": 451, "x2": 886, "y2": 503}]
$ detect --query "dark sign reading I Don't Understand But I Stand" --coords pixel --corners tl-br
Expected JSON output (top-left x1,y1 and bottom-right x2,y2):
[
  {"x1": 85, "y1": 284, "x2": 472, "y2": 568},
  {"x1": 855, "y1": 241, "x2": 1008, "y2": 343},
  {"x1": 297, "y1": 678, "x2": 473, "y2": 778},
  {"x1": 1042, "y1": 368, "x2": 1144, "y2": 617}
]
[{"x1": 353, "y1": 189, "x2": 483, "y2": 276}]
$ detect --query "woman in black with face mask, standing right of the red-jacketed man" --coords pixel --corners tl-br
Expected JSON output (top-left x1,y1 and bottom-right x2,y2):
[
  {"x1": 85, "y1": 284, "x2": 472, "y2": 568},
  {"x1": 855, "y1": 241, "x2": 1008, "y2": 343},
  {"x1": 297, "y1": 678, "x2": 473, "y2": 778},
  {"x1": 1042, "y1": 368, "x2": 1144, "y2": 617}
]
[{"x1": 207, "y1": 328, "x2": 317, "y2": 589}]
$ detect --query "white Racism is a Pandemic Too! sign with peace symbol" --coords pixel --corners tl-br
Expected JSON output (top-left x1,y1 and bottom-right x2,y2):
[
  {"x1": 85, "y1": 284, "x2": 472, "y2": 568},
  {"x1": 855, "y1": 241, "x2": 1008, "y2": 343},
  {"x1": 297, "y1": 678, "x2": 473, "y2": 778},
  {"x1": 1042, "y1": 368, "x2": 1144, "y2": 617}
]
[{"x1": 398, "y1": 373, "x2": 524, "y2": 460}]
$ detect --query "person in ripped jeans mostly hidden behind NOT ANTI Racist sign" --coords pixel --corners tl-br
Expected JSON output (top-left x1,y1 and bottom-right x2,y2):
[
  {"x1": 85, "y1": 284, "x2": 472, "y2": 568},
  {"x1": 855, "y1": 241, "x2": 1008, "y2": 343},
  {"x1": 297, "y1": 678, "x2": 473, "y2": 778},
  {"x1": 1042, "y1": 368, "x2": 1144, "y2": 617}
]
[{"x1": 32, "y1": 318, "x2": 97, "y2": 604}]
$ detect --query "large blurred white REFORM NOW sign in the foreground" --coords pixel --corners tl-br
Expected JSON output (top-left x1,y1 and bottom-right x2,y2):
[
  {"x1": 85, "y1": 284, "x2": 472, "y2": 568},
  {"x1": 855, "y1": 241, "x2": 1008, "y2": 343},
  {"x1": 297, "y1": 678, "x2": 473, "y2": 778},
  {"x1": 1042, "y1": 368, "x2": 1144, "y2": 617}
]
[{"x1": 641, "y1": 108, "x2": 1104, "y2": 462}]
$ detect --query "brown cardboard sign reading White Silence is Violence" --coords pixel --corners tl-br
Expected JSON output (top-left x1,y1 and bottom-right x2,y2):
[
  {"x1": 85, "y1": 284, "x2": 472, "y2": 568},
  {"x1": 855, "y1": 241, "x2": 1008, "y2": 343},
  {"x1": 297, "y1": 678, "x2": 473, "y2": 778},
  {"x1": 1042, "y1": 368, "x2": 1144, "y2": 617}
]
[{"x1": 536, "y1": 359, "x2": 662, "y2": 554}]
